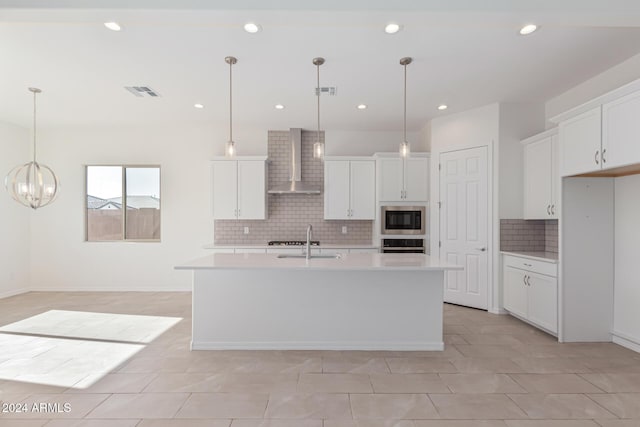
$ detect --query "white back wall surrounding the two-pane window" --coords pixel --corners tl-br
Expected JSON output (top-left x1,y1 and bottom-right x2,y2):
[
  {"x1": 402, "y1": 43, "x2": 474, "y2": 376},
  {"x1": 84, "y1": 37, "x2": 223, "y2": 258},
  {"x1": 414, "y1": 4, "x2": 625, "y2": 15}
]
[{"x1": 31, "y1": 126, "x2": 230, "y2": 290}]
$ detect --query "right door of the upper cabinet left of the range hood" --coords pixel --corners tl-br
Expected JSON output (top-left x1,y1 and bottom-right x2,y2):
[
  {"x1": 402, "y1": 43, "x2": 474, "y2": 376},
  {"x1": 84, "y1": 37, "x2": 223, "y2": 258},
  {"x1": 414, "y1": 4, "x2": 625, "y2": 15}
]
[{"x1": 238, "y1": 160, "x2": 267, "y2": 219}]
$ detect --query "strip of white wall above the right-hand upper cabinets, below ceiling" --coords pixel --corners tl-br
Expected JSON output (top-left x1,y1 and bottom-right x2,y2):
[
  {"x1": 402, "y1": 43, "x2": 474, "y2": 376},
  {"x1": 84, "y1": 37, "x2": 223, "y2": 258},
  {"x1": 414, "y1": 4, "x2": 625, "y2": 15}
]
[{"x1": 545, "y1": 54, "x2": 640, "y2": 122}]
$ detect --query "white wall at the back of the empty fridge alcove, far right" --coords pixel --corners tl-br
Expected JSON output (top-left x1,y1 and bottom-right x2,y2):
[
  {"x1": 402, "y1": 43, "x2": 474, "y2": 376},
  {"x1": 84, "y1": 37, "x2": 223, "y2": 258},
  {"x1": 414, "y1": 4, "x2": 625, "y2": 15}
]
[{"x1": 613, "y1": 175, "x2": 640, "y2": 350}]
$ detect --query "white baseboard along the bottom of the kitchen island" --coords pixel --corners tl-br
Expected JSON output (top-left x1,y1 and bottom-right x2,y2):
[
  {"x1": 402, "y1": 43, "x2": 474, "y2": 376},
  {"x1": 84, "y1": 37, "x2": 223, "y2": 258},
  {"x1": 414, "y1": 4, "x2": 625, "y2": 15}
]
[{"x1": 191, "y1": 341, "x2": 444, "y2": 351}]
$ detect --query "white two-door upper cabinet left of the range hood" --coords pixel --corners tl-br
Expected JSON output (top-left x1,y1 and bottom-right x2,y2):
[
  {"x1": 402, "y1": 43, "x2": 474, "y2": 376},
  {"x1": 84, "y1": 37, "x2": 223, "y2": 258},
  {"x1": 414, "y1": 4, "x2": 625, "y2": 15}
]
[{"x1": 211, "y1": 158, "x2": 267, "y2": 220}]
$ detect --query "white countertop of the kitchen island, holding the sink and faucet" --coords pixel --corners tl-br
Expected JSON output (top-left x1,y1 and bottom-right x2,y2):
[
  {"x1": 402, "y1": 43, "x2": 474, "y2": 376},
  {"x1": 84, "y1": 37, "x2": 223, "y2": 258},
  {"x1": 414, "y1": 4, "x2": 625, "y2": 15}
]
[{"x1": 175, "y1": 253, "x2": 463, "y2": 271}]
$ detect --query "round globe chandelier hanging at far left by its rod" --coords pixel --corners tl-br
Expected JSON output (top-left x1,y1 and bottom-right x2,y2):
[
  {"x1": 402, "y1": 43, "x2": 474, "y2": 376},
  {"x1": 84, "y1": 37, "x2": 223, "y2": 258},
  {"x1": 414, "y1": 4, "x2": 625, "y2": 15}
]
[{"x1": 4, "y1": 87, "x2": 60, "y2": 209}]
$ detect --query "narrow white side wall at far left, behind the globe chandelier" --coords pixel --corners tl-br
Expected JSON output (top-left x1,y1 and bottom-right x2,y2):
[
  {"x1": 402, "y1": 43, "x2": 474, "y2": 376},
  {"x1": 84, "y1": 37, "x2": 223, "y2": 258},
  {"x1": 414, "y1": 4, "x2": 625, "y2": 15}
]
[{"x1": 0, "y1": 123, "x2": 31, "y2": 298}]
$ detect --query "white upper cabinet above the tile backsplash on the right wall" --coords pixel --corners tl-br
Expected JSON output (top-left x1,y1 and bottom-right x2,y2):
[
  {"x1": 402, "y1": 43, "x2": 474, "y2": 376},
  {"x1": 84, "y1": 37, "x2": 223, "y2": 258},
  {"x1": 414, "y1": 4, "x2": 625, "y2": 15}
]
[{"x1": 522, "y1": 130, "x2": 560, "y2": 219}]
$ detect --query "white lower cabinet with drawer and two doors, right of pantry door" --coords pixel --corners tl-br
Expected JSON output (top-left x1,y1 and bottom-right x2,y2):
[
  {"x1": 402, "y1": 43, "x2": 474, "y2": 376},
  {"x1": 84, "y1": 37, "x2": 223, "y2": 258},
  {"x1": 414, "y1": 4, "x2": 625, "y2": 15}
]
[{"x1": 503, "y1": 255, "x2": 558, "y2": 334}]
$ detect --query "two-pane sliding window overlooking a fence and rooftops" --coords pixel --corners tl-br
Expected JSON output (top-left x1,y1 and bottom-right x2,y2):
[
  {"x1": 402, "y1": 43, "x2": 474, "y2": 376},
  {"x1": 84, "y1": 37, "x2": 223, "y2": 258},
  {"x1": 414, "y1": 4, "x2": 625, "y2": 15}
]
[{"x1": 86, "y1": 166, "x2": 160, "y2": 242}]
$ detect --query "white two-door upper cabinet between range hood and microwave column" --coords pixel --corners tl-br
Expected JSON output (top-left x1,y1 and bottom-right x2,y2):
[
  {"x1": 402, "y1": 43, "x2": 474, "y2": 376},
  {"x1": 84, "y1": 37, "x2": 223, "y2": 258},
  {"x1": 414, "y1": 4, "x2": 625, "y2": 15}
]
[{"x1": 324, "y1": 159, "x2": 376, "y2": 220}]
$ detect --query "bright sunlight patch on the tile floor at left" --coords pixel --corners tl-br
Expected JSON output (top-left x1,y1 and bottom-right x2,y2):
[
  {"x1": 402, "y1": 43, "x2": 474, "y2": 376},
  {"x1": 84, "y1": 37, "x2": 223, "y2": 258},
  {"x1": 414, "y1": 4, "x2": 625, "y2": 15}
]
[{"x1": 0, "y1": 310, "x2": 182, "y2": 388}]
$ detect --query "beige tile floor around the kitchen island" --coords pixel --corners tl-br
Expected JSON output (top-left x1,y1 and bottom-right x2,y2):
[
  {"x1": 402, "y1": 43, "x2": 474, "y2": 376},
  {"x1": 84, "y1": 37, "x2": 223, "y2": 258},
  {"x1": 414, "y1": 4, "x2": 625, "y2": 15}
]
[{"x1": 0, "y1": 292, "x2": 640, "y2": 427}]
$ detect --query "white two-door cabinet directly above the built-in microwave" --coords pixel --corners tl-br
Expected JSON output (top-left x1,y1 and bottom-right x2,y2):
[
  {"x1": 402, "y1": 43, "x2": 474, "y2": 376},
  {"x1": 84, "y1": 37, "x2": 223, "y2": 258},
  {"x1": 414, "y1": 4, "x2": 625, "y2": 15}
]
[{"x1": 378, "y1": 157, "x2": 429, "y2": 202}]
